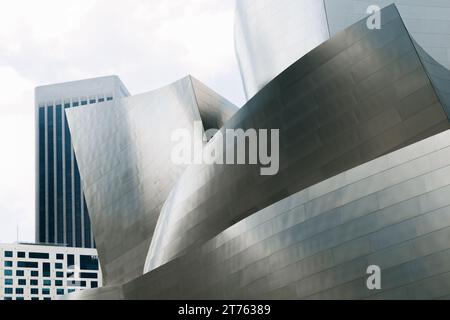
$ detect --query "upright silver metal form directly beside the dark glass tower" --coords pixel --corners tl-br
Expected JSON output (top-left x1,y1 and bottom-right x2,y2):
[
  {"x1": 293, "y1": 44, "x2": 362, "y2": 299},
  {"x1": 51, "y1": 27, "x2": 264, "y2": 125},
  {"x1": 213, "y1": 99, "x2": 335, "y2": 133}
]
[{"x1": 67, "y1": 77, "x2": 237, "y2": 285}]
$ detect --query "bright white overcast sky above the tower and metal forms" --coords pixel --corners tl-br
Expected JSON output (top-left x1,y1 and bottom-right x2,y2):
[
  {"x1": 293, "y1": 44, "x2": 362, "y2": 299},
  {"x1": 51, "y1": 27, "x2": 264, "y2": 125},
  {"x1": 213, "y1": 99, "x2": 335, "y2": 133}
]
[{"x1": 0, "y1": 0, "x2": 244, "y2": 243}]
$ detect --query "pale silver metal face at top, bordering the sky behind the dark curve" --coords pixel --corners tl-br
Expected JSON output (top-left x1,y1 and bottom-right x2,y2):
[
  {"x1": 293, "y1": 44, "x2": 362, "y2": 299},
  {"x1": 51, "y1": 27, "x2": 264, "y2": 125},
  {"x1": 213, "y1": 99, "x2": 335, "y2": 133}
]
[{"x1": 235, "y1": 0, "x2": 329, "y2": 99}]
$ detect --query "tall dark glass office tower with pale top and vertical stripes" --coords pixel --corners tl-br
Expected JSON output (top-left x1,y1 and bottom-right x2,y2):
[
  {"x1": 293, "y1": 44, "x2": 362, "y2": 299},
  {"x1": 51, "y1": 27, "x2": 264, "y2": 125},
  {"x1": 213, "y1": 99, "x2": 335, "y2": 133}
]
[{"x1": 35, "y1": 76, "x2": 129, "y2": 248}]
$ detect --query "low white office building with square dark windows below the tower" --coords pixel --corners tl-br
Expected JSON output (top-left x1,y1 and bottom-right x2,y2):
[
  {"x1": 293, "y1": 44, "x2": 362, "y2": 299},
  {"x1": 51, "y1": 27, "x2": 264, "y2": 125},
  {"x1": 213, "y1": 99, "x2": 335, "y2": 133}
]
[{"x1": 0, "y1": 244, "x2": 102, "y2": 300}]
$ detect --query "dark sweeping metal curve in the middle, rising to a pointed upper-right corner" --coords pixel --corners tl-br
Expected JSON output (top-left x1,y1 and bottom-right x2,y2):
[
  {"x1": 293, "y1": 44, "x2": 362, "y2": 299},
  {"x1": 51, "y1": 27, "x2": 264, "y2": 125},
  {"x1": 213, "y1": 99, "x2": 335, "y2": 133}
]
[{"x1": 146, "y1": 7, "x2": 450, "y2": 271}]
